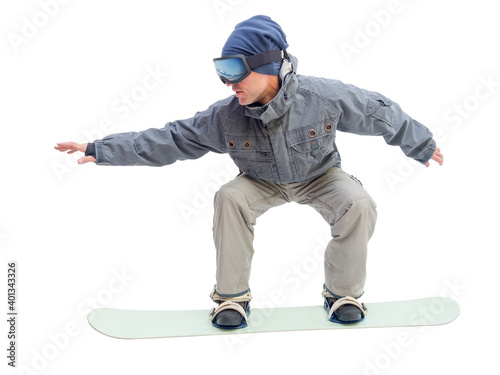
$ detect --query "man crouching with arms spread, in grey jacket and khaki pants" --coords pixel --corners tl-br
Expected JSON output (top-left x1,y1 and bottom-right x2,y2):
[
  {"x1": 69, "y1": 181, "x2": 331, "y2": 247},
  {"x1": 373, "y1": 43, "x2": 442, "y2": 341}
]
[{"x1": 56, "y1": 16, "x2": 443, "y2": 328}]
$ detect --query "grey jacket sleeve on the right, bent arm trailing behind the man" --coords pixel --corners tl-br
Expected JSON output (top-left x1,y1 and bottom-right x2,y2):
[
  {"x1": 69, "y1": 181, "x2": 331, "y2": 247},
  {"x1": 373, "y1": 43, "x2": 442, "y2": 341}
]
[{"x1": 330, "y1": 83, "x2": 436, "y2": 164}]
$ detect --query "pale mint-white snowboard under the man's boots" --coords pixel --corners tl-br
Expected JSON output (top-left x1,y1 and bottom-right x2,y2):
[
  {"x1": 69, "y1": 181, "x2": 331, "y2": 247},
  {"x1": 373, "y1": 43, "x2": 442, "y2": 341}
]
[{"x1": 87, "y1": 297, "x2": 460, "y2": 339}]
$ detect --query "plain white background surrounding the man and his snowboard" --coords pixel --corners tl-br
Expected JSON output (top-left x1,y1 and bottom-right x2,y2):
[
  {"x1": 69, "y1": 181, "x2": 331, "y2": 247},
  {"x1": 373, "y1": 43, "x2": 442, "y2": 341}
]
[{"x1": 0, "y1": 0, "x2": 500, "y2": 374}]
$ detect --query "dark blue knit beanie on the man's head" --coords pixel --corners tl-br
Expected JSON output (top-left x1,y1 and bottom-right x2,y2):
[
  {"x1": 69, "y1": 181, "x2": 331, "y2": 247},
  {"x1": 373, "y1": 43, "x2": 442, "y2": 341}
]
[{"x1": 222, "y1": 16, "x2": 288, "y2": 76}]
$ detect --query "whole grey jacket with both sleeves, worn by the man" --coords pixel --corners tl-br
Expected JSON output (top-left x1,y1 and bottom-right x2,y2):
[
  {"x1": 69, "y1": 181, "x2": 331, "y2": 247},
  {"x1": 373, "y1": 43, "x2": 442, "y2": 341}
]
[{"x1": 95, "y1": 56, "x2": 436, "y2": 184}]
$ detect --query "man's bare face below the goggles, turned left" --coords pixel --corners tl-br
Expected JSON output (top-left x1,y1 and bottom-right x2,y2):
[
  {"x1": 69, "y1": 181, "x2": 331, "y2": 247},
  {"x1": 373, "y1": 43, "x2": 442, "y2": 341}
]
[{"x1": 226, "y1": 72, "x2": 279, "y2": 105}]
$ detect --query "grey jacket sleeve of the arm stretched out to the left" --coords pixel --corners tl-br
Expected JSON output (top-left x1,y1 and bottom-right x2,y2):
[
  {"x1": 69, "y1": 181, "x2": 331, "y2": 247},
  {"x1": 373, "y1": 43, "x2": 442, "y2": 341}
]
[{"x1": 95, "y1": 102, "x2": 226, "y2": 167}]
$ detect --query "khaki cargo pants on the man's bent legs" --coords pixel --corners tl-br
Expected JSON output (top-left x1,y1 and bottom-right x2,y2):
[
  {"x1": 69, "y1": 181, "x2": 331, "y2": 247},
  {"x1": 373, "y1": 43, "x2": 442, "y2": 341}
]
[{"x1": 213, "y1": 168, "x2": 377, "y2": 300}]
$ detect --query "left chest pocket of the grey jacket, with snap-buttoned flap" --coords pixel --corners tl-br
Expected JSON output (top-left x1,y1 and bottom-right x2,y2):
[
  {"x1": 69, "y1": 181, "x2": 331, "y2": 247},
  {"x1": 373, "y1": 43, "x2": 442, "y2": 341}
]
[{"x1": 226, "y1": 135, "x2": 276, "y2": 181}]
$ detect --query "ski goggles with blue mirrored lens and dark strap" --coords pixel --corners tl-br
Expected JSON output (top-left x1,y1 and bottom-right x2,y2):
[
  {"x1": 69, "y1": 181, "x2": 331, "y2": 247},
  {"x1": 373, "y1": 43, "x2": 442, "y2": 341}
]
[{"x1": 214, "y1": 51, "x2": 285, "y2": 85}]
